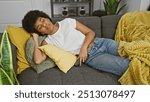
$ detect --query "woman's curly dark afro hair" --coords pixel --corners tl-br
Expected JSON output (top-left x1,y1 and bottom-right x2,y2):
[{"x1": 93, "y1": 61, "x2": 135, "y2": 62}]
[{"x1": 22, "y1": 10, "x2": 52, "y2": 35}]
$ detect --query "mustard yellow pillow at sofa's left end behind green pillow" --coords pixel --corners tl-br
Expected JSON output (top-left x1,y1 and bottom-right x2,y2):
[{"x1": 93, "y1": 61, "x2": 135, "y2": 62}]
[{"x1": 7, "y1": 25, "x2": 30, "y2": 74}]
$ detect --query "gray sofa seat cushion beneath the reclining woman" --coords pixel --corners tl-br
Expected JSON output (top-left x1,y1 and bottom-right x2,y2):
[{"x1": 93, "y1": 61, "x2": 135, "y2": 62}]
[{"x1": 18, "y1": 64, "x2": 119, "y2": 85}]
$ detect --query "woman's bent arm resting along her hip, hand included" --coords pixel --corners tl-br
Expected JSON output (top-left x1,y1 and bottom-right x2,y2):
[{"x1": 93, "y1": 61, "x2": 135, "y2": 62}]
[{"x1": 76, "y1": 21, "x2": 95, "y2": 65}]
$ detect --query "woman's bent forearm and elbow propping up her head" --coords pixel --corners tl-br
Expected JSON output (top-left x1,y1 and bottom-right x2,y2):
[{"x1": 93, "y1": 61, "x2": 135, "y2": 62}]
[{"x1": 32, "y1": 33, "x2": 47, "y2": 64}]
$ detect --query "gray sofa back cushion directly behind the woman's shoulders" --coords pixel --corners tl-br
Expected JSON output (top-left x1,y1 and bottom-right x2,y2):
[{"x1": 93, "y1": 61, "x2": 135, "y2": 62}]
[{"x1": 52, "y1": 16, "x2": 101, "y2": 37}]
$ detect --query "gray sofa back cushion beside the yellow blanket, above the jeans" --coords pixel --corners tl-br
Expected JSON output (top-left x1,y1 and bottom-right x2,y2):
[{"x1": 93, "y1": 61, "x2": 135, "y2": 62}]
[{"x1": 101, "y1": 15, "x2": 122, "y2": 39}]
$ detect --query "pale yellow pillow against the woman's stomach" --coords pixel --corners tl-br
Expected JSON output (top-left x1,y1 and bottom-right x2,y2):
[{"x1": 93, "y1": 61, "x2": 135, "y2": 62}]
[{"x1": 39, "y1": 45, "x2": 77, "y2": 73}]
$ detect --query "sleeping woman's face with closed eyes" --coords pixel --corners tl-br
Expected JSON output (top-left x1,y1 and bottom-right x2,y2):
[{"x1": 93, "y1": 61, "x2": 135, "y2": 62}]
[{"x1": 34, "y1": 17, "x2": 53, "y2": 34}]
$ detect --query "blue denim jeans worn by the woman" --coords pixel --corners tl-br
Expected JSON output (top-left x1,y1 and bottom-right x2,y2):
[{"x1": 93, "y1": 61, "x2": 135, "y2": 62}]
[{"x1": 85, "y1": 38, "x2": 129, "y2": 76}]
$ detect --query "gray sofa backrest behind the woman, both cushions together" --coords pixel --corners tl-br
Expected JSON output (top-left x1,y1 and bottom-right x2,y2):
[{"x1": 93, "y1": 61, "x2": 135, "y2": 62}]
[{"x1": 52, "y1": 15, "x2": 122, "y2": 39}]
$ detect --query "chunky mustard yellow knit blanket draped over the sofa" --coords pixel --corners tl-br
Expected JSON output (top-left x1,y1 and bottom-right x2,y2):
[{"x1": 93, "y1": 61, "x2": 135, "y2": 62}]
[{"x1": 115, "y1": 11, "x2": 150, "y2": 85}]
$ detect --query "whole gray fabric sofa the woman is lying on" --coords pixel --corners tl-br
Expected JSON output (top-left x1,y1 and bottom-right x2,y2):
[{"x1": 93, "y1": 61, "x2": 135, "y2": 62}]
[{"x1": 0, "y1": 15, "x2": 121, "y2": 85}]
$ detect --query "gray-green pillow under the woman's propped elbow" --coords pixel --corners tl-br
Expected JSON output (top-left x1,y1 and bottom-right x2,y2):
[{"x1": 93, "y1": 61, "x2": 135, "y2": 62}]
[{"x1": 25, "y1": 36, "x2": 56, "y2": 73}]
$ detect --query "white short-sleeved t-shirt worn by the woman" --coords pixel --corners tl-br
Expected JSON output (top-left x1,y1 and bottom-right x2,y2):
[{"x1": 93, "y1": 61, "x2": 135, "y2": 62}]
[{"x1": 45, "y1": 18, "x2": 85, "y2": 54}]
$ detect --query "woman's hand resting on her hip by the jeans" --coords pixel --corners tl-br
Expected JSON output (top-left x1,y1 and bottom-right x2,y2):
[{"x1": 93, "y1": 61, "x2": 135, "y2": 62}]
[{"x1": 78, "y1": 47, "x2": 88, "y2": 66}]
